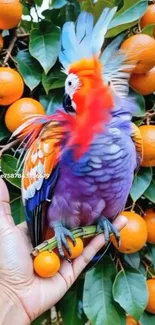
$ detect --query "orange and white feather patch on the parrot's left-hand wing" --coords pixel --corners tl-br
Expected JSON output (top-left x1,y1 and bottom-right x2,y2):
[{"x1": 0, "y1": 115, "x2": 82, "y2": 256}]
[{"x1": 23, "y1": 122, "x2": 63, "y2": 199}]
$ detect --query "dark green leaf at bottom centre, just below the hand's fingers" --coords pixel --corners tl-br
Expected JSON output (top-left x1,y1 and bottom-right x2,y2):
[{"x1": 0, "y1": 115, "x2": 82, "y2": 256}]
[{"x1": 58, "y1": 279, "x2": 87, "y2": 325}]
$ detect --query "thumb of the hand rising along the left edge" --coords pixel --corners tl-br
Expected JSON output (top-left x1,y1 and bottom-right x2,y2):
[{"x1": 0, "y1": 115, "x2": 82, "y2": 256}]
[{"x1": 0, "y1": 177, "x2": 15, "y2": 232}]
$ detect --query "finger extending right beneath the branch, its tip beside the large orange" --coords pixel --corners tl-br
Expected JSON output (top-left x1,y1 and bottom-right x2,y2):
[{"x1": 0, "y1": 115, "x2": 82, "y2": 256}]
[{"x1": 73, "y1": 216, "x2": 127, "y2": 279}]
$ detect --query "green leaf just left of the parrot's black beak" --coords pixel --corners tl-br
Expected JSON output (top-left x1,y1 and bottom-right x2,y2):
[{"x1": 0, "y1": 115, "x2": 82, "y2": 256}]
[{"x1": 39, "y1": 89, "x2": 64, "y2": 115}]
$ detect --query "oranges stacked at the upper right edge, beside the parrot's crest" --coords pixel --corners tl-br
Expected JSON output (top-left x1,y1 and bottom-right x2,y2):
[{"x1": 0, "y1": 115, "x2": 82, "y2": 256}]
[{"x1": 121, "y1": 4, "x2": 155, "y2": 95}]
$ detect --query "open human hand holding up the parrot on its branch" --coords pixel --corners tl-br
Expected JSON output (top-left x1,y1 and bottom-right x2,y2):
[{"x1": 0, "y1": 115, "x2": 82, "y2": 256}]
[{"x1": 0, "y1": 178, "x2": 127, "y2": 325}]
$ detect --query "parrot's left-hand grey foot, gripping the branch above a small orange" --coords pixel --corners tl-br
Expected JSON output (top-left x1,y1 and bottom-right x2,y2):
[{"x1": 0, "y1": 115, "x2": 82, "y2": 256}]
[{"x1": 52, "y1": 221, "x2": 76, "y2": 257}]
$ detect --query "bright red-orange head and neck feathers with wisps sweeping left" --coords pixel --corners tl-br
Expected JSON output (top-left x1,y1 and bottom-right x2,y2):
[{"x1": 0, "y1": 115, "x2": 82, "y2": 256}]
[{"x1": 13, "y1": 57, "x2": 113, "y2": 159}]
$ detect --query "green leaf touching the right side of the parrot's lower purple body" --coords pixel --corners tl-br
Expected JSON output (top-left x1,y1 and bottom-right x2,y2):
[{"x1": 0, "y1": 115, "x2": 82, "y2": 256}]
[{"x1": 130, "y1": 167, "x2": 152, "y2": 202}]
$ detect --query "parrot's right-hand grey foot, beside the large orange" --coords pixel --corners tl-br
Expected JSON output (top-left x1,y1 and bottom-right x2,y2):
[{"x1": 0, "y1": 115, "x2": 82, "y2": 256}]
[{"x1": 97, "y1": 217, "x2": 120, "y2": 247}]
